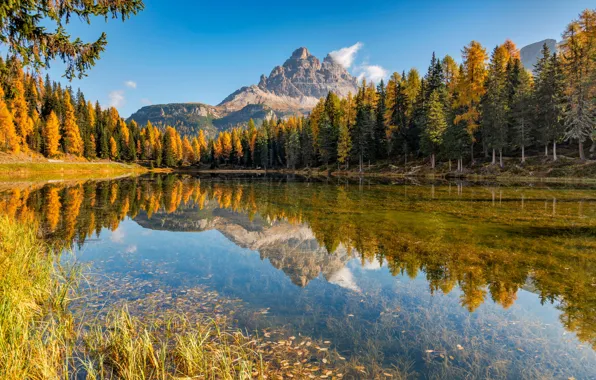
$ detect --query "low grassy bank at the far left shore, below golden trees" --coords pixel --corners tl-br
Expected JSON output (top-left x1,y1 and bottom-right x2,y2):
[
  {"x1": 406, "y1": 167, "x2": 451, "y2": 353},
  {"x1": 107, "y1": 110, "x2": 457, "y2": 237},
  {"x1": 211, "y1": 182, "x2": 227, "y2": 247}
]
[{"x1": 0, "y1": 161, "x2": 148, "y2": 181}]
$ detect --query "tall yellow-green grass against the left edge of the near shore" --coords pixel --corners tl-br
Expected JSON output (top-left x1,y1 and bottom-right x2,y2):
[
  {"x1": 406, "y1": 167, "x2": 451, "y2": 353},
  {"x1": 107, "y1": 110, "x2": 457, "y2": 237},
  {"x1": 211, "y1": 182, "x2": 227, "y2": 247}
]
[{"x1": 0, "y1": 216, "x2": 75, "y2": 379}]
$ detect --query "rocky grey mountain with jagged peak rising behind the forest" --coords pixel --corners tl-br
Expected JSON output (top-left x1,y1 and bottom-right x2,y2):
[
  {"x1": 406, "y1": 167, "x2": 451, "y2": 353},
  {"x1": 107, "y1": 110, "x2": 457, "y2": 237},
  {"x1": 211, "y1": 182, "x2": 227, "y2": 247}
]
[{"x1": 129, "y1": 47, "x2": 358, "y2": 134}]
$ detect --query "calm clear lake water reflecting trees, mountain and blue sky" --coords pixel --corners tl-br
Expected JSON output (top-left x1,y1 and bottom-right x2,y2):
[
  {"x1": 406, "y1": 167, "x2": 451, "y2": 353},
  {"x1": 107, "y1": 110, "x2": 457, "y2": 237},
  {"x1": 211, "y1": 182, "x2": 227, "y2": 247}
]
[{"x1": 0, "y1": 175, "x2": 596, "y2": 379}]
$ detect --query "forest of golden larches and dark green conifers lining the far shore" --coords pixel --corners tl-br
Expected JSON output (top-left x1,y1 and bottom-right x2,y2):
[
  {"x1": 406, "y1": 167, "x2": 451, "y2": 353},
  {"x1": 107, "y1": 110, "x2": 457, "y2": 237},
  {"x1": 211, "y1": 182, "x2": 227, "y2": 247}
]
[{"x1": 0, "y1": 10, "x2": 596, "y2": 172}]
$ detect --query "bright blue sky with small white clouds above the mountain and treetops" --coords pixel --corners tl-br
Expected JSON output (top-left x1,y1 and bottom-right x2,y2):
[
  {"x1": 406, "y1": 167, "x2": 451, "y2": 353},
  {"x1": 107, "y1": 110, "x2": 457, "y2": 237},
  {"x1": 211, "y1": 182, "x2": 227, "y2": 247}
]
[{"x1": 42, "y1": 0, "x2": 594, "y2": 117}]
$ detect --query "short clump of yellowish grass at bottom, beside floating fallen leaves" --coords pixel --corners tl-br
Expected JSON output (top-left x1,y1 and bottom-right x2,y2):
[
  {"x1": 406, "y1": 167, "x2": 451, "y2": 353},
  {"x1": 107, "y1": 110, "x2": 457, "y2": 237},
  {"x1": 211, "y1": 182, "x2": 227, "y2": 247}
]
[{"x1": 82, "y1": 307, "x2": 270, "y2": 380}]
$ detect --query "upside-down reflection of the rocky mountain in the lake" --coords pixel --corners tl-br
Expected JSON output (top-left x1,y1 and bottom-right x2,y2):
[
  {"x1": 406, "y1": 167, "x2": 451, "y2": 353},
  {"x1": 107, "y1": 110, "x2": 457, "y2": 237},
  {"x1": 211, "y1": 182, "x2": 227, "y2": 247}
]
[{"x1": 134, "y1": 201, "x2": 358, "y2": 284}]
